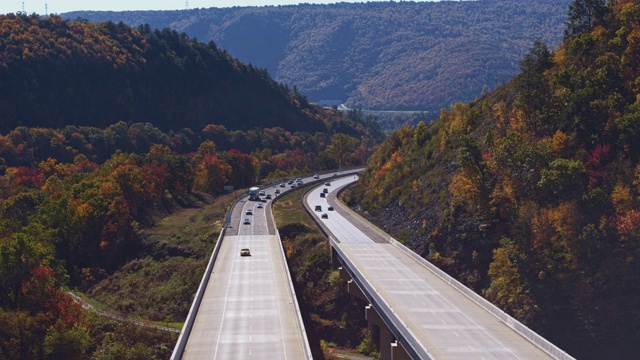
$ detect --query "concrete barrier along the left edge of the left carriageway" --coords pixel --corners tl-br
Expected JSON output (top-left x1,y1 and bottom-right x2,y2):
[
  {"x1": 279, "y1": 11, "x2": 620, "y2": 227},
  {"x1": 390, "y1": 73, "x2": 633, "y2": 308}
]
[{"x1": 171, "y1": 196, "x2": 243, "y2": 360}]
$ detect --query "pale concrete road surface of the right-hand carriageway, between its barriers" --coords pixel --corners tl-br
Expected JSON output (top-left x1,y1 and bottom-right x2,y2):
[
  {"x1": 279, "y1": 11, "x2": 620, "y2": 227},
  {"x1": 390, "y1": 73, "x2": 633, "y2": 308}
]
[{"x1": 306, "y1": 177, "x2": 564, "y2": 360}]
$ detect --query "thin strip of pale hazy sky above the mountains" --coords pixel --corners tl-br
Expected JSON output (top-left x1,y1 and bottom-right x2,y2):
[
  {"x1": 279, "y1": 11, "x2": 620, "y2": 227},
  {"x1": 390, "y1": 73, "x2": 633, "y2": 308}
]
[{"x1": 0, "y1": 0, "x2": 437, "y2": 14}]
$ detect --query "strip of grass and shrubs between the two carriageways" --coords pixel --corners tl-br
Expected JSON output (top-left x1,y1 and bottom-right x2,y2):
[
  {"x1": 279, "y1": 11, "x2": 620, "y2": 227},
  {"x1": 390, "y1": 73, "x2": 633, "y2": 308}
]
[{"x1": 273, "y1": 189, "x2": 370, "y2": 359}]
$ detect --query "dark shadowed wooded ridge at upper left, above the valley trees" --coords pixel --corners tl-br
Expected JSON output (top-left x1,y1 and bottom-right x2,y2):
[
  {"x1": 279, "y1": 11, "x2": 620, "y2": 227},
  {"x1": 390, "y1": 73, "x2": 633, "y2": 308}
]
[{"x1": 0, "y1": 14, "x2": 331, "y2": 133}]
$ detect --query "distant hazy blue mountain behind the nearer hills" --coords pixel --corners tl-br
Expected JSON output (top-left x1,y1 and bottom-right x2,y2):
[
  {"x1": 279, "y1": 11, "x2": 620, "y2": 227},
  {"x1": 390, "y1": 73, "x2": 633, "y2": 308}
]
[{"x1": 63, "y1": 0, "x2": 570, "y2": 111}]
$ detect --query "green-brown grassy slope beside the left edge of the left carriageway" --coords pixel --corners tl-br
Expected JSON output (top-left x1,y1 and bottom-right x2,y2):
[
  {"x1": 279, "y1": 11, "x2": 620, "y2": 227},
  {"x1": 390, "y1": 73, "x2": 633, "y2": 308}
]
[{"x1": 82, "y1": 194, "x2": 235, "y2": 328}]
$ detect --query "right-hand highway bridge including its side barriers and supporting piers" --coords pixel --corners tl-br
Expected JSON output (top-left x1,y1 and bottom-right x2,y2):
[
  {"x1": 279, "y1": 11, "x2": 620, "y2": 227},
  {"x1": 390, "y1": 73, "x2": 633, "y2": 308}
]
[{"x1": 304, "y1": 177, "x2": 572, "y2": 360}]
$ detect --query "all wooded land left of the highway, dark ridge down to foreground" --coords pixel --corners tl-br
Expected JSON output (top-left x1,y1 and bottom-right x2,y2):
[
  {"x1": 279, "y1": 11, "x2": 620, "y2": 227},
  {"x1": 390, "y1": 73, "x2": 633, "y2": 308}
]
[{"x1": 0, "y1": 15, "x2": 382, "y2": 359}]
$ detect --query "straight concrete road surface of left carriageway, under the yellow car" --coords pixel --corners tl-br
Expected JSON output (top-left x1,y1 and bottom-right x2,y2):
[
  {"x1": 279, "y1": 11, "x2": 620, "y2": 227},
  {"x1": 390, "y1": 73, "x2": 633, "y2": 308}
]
[{"x1": 183, "y1": 188, "x2": 306, "y2": 359}]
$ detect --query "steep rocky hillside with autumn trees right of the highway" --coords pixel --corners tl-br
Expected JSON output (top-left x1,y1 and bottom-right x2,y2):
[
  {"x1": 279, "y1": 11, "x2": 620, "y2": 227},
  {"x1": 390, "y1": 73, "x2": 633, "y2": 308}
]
[{"x1": 351, "y1": 0, "x2": 640, "y2": 359}]
